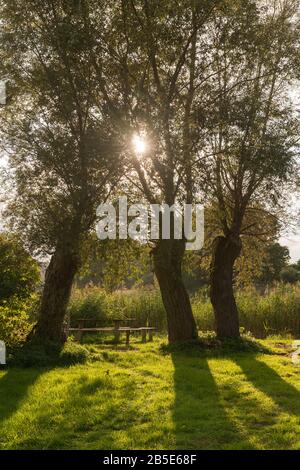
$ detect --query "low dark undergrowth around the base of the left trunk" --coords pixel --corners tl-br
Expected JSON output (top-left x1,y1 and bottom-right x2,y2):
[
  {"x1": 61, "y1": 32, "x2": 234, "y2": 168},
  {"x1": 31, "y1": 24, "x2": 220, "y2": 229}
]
[{"x1": 8, "y1": 340, "x2": 89, "y2": 367}]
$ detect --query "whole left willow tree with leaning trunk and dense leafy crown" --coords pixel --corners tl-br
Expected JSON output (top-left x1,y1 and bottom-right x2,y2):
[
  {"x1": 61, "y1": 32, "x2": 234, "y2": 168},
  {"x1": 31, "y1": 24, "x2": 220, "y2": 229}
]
[{"x1": 1, "y1": 0, "x2": 119, "y2": 342}]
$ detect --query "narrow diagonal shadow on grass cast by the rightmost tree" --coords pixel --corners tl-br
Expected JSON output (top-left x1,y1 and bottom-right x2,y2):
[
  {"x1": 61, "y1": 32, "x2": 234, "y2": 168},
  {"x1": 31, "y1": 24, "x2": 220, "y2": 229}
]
[{"x1": 233, "y1": 355, "x2": 300, "y2": 417}]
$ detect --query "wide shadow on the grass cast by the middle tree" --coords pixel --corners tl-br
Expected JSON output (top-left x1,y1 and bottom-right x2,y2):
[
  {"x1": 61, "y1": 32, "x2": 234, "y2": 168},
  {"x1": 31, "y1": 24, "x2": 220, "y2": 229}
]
[{"x1": 172, "y1": 353, "x2": 253, "y2": 450}]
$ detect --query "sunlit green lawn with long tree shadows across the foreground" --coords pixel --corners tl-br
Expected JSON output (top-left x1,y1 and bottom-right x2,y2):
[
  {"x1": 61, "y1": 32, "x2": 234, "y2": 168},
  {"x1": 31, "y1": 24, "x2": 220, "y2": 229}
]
[{"x1": 0, "y1": 340, "x2": 300, "y2": 449}]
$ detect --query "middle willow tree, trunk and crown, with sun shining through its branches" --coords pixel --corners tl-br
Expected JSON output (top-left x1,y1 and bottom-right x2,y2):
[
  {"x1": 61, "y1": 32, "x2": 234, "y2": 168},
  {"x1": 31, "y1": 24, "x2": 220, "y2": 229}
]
[{"x1": 86, "y1": 0, "x2": 219, "y2": 342}]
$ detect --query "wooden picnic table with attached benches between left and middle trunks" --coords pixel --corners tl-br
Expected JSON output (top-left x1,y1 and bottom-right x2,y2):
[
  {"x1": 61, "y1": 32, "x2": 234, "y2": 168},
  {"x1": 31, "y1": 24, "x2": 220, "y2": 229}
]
[{"x1": 68, "y1": 318, "x2": 156, "y2": 346}]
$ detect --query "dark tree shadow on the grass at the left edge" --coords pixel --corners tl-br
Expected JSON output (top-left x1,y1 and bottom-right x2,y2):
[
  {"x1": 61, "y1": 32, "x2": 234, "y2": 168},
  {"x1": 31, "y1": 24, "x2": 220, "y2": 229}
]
[{"x1": 0, "y1": 369, "x2": 41, "y2": 425}]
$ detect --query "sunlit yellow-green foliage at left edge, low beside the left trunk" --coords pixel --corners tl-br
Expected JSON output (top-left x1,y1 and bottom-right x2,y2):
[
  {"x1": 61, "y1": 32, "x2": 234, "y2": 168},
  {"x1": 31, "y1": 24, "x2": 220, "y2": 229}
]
[{"x1": 0, "y1": 295, "x2": 37, "y2": 347}]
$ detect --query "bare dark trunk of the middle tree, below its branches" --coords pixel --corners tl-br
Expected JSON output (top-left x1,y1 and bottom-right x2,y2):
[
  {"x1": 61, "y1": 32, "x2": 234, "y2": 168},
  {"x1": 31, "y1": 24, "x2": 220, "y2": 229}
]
[{"x1": 153, "y1": 240, "x2": 198, "y2": 343}]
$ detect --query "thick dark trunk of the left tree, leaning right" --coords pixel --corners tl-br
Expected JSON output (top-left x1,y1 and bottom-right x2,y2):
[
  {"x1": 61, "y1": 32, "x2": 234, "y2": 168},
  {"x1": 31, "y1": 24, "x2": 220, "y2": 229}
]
[{"x1": 33, "y1": 247, "x2": 79, "y2": 343}]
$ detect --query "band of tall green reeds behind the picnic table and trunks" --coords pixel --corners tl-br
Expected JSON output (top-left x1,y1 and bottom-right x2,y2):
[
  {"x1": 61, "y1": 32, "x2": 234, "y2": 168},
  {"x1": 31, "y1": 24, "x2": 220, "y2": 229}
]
[{"x1": 69, "y1": 284, "x2": 300, "y2": 338}]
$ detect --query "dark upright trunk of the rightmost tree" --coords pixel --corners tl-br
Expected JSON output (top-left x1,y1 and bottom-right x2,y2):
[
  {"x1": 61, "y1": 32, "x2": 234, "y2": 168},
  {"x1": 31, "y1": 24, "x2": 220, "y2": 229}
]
[{"x1": 210, "y1": 236, "x2": 242, "y2": 338}]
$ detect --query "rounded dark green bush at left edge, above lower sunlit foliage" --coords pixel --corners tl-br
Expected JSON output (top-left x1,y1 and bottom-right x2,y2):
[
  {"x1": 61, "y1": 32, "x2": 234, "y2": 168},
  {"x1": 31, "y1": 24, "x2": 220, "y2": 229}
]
[{"x1": 0, "y1": 234, "x2": 40, "y2": 303}]
